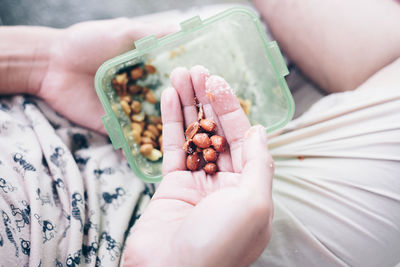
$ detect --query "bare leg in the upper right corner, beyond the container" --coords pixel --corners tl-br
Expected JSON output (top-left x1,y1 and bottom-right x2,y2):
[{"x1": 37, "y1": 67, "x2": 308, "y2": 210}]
[{"x1": 254, "y1": 0, "x2": 400, "y2": 92}]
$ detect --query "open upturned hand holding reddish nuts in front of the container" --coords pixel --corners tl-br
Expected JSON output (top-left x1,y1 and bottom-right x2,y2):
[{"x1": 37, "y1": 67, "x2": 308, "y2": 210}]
[{"x1": 125, "y1": 66, "x2": 273, "y2": 266}]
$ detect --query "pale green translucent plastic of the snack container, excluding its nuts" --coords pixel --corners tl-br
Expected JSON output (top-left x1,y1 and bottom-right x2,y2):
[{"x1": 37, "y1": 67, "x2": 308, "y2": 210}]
[{"x1": 97, "y1": 8, "x2": 292, "y2": 181}]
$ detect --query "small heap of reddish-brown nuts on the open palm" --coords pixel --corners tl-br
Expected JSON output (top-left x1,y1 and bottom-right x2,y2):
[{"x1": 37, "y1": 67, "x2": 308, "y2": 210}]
[{"x1": 183, "y1": 104, "x2": 226, "y2": 175}]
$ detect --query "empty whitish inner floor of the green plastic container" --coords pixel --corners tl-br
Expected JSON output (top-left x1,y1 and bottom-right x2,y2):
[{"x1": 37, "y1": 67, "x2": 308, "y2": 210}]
[{"x1": 147, "y1": 12, "x2": 289, "y2": 129}]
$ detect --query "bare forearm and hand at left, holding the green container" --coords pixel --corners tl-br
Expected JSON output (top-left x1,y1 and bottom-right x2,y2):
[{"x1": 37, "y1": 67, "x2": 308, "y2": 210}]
[{"x1": 0, "y1": 18, "x2": 177, "y2": 134}]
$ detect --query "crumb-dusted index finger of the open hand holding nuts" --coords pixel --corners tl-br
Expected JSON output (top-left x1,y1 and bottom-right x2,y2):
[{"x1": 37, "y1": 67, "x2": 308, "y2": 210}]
[{"x1": 206, "y1": 75, "x2": 251, "y2": 172}]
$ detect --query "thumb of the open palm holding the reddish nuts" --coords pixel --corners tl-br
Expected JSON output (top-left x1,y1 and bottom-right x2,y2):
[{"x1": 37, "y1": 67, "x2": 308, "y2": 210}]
[{"x1": 241, "y1": 125, "x2": 274, "y2": 198}]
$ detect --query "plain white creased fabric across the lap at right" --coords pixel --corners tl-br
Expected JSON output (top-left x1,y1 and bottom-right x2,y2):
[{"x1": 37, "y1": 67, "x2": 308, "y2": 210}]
[{"x1": 254, "y1": 59, "x2": 400, "y2": 266}]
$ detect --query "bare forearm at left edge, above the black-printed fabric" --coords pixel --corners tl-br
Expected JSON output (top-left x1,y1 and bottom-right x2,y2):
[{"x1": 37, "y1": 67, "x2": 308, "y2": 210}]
[{"x1": 0, "y1": 26, "x2": 58, "y2": 94}]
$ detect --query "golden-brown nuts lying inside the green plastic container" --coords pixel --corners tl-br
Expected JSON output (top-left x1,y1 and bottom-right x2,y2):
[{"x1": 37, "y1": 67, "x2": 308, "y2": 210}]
[{"x1": 111, "y1": 64, "x2": 163, "y2": 161}]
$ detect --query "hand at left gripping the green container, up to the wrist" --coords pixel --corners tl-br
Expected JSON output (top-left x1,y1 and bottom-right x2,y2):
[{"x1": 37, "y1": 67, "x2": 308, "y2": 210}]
[{"x1": 37, "y1": 18, "x2": 175, "y2": 133}]
